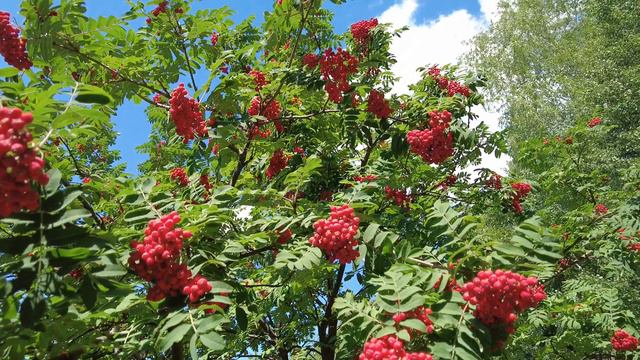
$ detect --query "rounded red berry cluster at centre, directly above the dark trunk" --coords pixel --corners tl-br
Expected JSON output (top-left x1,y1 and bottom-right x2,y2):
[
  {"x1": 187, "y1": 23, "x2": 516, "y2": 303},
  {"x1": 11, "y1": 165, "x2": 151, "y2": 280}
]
[{"x1": 309, "y1": 204, "x2": 360, "y2": 264}]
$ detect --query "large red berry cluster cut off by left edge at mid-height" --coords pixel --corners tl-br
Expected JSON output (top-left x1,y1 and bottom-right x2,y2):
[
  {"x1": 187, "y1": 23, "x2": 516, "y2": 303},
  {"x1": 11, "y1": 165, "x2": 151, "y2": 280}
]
[{"x1": 0, "y1": 108, "x2": 49, "y2": 218}]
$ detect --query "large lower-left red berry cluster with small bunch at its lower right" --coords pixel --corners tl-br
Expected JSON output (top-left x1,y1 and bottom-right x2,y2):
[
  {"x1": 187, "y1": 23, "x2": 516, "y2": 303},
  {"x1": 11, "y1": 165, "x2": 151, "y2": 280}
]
[{"x1": 129, "y1": 211, "x2": 211, "y2": 302}]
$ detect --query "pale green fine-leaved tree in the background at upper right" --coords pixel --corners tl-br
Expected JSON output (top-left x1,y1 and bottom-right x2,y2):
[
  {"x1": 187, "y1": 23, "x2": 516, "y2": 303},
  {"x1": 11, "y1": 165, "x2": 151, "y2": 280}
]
[{"x1": 466, "y1": 0, "x2": 640, "y2": 161}]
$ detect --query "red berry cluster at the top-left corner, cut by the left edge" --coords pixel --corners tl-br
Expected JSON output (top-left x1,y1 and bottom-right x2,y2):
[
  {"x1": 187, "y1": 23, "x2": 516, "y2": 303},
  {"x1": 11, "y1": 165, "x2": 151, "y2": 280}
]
[{"x1": 0, "y1": 11, "x2": 33, "y2": 70}]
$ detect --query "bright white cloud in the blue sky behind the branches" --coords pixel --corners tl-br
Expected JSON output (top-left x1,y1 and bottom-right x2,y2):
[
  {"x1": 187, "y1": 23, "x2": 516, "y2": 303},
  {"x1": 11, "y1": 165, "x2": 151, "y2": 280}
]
[{"x1": 378, "y1": 0, "x2": 509, "y2": 173}]
